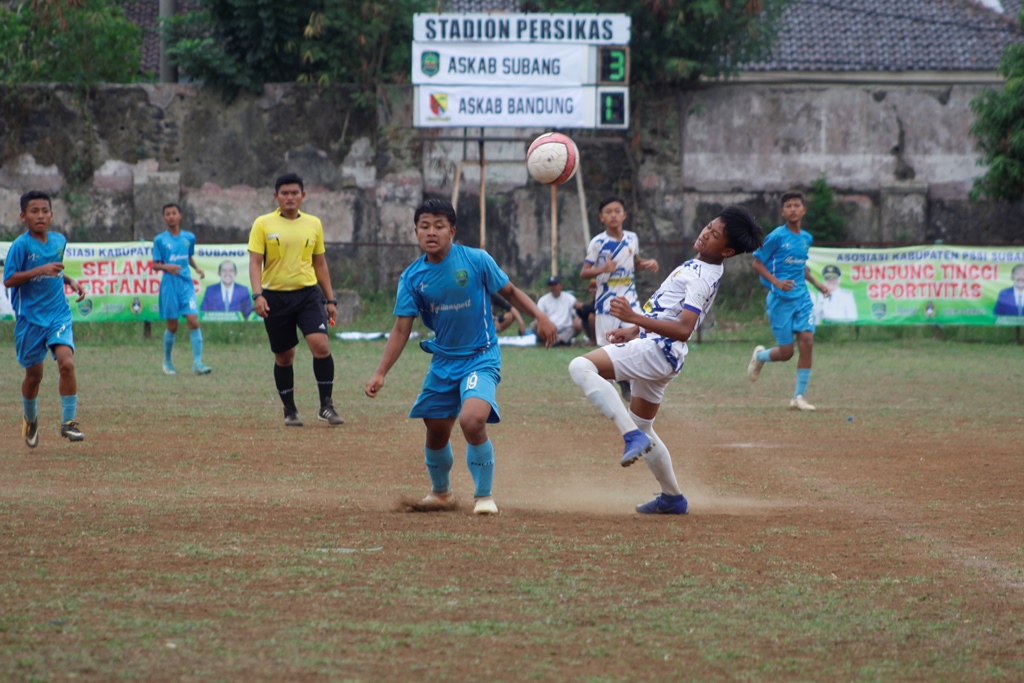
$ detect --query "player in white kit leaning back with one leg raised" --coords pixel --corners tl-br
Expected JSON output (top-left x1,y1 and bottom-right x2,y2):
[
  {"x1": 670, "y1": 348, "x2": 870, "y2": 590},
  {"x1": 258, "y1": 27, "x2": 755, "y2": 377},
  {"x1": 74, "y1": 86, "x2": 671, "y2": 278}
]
[{"x1": 569, "y1": 206, "x2": 764, "y2": 515}]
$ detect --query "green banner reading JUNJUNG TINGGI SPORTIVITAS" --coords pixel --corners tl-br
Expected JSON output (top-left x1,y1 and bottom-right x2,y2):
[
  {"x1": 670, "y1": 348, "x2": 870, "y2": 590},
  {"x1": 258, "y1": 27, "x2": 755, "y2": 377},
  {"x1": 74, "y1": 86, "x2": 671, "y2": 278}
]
[{"x1": 807, "y1": 245, "x2": 1024, "y2": 326}]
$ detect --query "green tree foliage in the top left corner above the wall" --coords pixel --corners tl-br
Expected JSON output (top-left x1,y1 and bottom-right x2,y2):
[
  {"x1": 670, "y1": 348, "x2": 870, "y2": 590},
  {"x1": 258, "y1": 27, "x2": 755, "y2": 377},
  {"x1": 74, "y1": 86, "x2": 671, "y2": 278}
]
[{"x1": 0, "y1": 0, "x2": 142, "y2": 85}]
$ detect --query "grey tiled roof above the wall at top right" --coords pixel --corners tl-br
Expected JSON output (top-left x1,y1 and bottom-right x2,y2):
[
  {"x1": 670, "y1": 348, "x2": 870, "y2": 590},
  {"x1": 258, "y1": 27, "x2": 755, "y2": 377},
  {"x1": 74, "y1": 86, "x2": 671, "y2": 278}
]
[{"x1": 741, "y1": 0, "x2": 1024, "y2": 72}]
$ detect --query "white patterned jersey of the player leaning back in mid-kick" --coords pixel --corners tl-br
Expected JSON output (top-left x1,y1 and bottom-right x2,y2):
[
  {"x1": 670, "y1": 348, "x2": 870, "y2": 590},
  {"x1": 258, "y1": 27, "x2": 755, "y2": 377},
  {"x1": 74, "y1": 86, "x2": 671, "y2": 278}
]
[{"x1": 640, "y1": 258, "x2": 725, "y2": 372}]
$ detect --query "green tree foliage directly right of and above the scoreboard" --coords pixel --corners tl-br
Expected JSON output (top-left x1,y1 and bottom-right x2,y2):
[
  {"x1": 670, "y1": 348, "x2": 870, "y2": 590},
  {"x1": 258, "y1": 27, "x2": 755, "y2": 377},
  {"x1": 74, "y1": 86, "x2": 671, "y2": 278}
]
[{"x1": 534, "y1": 0, "x2": 792, "y2": 88}]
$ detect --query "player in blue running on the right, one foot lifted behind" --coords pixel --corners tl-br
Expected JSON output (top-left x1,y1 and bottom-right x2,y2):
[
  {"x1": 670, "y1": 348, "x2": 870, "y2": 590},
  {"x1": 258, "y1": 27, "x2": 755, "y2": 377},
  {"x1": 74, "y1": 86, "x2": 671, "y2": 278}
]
[{"x1": 746, "y1": 190, "x2": 828, "y2": 411}]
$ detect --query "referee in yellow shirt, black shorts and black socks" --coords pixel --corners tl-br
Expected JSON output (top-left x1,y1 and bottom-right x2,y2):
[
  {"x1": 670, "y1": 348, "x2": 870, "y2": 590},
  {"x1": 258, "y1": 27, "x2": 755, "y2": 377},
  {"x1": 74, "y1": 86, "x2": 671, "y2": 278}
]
[{"x1": 249, "y1": 173, "x2": 345, "y2": 427}]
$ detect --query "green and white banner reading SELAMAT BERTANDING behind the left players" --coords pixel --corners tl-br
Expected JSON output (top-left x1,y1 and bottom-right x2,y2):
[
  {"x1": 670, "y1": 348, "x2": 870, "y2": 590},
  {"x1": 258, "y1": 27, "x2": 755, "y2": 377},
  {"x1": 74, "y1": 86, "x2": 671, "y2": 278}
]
[{"x1": 0, "y1": 242, "x2": 260, "y2": 323}]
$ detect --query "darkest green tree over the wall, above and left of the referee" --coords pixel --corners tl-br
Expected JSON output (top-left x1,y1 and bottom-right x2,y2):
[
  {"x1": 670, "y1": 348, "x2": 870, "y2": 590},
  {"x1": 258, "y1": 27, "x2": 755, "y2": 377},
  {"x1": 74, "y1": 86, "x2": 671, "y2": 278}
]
[{"x1": 163, "y1": 0, "x2": 322, "y2": 100}]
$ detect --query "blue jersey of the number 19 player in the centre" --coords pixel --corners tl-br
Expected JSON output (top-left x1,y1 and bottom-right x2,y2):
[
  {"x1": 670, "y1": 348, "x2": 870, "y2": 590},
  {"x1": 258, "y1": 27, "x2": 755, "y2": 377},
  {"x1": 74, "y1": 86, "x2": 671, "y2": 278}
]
[{"x1": 394, "y1": 245, "x2": 509, "y2": 359}]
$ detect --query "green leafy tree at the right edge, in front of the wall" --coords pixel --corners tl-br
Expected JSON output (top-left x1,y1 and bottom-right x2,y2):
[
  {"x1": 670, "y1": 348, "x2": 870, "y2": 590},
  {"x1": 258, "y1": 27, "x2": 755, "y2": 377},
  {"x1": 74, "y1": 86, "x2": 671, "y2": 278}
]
[{"x1": 971, "y1": 11, "x2": 1024, "y2": 202}]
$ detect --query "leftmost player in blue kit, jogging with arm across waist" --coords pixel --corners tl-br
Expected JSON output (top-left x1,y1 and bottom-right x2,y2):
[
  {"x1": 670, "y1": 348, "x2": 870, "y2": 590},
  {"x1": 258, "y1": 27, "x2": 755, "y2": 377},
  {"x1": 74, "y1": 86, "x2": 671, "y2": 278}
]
[{"x1": 3, "y1": 190, "x2": 85, "y2": 449}]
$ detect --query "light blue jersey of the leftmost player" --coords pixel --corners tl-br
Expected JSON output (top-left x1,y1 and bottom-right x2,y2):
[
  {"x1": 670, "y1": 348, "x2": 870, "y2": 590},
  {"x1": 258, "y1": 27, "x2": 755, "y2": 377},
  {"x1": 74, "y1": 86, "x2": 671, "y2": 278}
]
[{"x1": 3, "y1": 232, "x2": 71, "y2": 327}]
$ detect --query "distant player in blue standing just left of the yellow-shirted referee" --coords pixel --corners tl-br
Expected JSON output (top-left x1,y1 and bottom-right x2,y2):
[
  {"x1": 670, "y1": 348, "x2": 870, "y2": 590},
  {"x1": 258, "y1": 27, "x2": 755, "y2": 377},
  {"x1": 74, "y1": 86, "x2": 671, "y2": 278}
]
[{"x1": 153, "y1": 204, "x2": 213, "y2": 375}]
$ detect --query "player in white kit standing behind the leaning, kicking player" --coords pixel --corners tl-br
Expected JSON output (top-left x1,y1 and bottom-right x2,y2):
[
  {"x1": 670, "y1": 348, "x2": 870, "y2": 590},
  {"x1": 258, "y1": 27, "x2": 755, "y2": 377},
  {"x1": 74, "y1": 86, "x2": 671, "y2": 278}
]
[{"x1": 580, "y1": 197, "x2": 658, "y2": 400}]
